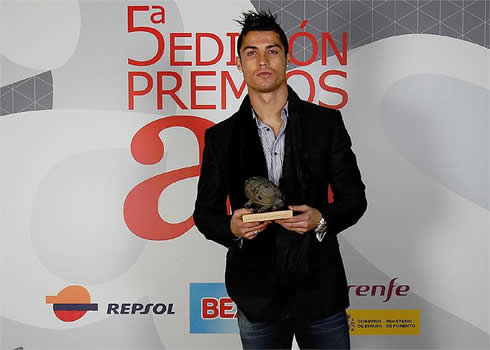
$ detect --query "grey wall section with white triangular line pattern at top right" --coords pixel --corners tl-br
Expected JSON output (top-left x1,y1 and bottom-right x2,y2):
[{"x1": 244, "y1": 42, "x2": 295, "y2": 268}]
[{"x1": 251, "y1": 0, "x2": 490, "y2": 59}]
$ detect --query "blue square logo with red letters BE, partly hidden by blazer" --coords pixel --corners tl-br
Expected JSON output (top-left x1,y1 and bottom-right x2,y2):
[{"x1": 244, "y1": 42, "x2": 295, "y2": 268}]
[{"x1": 189, "y1": 283, "x2": 238, "y2": 333}]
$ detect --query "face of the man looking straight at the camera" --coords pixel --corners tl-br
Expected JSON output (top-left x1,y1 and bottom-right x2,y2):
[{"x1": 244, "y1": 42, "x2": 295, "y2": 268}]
[{"x1": 237, "y1": 31, "x2": 289, "y2": 92}]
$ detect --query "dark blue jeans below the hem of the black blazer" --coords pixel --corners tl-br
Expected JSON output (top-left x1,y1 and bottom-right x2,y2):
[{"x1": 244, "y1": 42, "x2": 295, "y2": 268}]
[{"x1": 238, "y1": 310, "x2": 350, "y2": 349}]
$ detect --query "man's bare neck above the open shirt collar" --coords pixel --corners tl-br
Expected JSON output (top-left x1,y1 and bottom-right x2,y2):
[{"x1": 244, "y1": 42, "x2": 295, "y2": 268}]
[{"x1": 248, "y1": 84, "x2": 288, "y2": 125}]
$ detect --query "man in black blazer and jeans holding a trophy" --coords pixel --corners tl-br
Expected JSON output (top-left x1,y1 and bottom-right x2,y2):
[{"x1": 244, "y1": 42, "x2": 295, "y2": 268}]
[{"x1": 194, "y1": 12, "x2": 367, "y2": 349}]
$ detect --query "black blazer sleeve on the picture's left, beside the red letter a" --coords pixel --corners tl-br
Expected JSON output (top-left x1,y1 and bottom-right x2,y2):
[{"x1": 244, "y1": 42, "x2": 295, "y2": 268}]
[{"x1": 193, "y1": 129, "x2": 236, "y2": 247}]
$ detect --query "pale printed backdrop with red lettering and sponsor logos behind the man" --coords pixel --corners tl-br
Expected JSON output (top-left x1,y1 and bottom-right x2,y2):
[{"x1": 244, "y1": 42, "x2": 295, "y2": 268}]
[{"x1": 0, "y1": 0, "x2": 490, "y2": 349}]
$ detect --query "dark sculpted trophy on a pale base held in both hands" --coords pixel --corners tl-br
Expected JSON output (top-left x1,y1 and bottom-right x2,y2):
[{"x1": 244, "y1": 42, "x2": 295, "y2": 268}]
[{"x1": 242, "y1": 176, "x2": 293, "y2": 222}]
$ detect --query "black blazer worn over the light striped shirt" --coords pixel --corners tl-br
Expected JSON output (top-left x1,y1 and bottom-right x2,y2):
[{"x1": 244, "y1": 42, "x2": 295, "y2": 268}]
[{"x1": 194, "y1": 86, "x2": 367, "y2": 322}]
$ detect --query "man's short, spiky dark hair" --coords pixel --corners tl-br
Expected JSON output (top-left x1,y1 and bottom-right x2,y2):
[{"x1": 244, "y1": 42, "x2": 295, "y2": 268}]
[{"x1": 235, "y1": 10, "x2": 289, "y2": 56}]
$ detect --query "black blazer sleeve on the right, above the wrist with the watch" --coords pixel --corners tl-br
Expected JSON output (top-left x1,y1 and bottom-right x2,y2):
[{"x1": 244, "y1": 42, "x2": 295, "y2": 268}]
[{"x1": 321, "y1": 111, "x2": 367, "y2": 236}]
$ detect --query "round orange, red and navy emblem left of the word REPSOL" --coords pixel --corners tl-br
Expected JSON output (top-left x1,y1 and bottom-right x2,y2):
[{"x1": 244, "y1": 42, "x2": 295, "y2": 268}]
[{"x1": 46, "y1": 286, "x2": 98, "y2": 322}]
